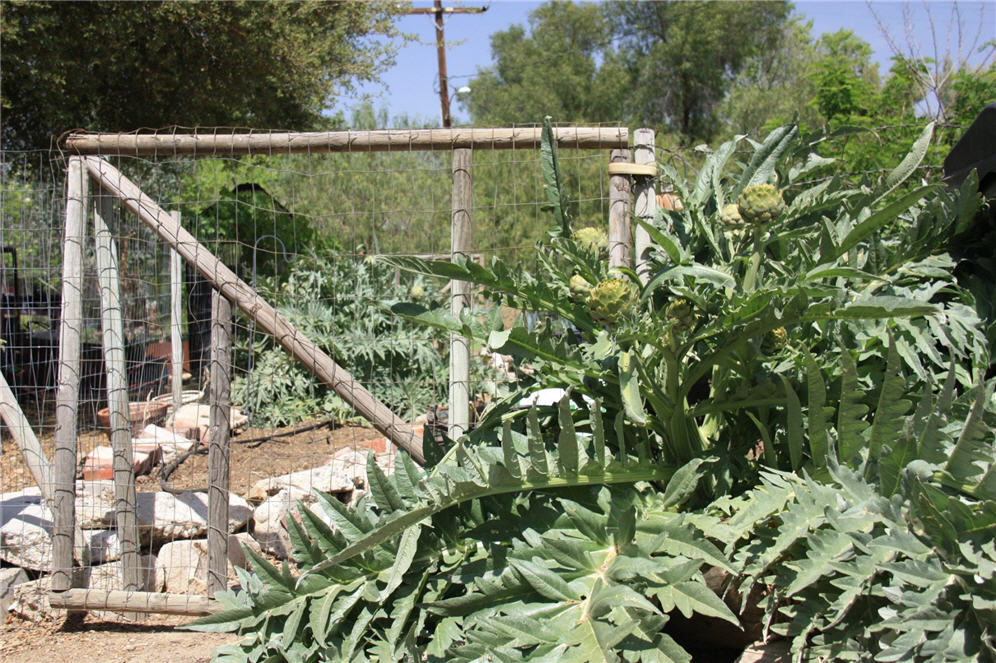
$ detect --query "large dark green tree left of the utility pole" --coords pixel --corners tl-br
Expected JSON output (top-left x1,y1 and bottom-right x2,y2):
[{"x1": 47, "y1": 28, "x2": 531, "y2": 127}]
[{"x1": 0, "y1": 0, "x2": 396, "y2": 149}]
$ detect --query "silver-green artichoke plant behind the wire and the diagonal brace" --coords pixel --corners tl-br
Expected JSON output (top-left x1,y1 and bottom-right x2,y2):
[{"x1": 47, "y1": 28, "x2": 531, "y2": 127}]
[{"x1": 233, "y1": 253, "x2": 447, "y2": 426}]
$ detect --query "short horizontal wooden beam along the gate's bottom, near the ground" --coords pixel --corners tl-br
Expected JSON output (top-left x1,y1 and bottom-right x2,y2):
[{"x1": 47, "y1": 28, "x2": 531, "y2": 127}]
[{"x1": 48, "y1": 589, "x2": 222, "y2": 616}]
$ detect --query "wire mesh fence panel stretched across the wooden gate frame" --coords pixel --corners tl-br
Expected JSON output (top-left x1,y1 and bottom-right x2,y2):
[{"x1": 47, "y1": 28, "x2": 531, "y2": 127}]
[{"x1": 0, "y1": 128, "x2": 620, "y2": 613}]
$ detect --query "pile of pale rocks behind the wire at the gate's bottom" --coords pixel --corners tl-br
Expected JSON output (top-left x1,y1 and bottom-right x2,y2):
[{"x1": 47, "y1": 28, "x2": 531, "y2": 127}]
[{"x1": 0, "y1": 433, "x2": 404, "y2": 619}]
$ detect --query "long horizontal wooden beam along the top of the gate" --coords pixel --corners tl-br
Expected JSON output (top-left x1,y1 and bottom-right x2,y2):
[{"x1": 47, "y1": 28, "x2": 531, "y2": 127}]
[{"x1": 65, "y1": 127, "x2": 629, "y2": 156}]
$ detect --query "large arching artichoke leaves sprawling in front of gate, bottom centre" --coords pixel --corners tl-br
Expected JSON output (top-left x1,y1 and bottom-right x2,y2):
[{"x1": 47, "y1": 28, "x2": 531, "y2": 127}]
[{"x1": 190, "y1": 399, "x2": 737, "y2": 662}]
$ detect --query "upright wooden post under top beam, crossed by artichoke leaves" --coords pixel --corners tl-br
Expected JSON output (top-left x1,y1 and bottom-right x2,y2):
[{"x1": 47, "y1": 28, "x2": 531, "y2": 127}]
[{"x1": 448, "y1": 148, "x2": 474, "y2": 440}]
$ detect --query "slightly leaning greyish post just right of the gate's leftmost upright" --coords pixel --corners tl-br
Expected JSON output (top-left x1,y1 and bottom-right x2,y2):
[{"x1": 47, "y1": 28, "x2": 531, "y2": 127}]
[{"x1": 93, "y1": 195, "x2": 144, "y2": 590}]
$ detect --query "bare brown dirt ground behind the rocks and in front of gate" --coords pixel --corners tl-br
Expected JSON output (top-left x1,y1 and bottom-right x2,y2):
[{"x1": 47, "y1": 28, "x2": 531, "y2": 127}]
[{"x1": 0, "y1": 410, "x2": 381, "y2": 663}]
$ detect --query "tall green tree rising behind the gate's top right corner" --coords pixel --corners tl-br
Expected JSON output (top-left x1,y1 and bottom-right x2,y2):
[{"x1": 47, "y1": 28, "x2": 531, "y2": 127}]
[{"x1": 607, "y1": 2, "x2": 790, "y2": 140}]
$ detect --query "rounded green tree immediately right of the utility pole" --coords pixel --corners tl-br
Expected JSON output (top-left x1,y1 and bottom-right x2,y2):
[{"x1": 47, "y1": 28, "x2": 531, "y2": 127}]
[{"x1": 468, "y1": 2, "x2": 627, "y2": 125}]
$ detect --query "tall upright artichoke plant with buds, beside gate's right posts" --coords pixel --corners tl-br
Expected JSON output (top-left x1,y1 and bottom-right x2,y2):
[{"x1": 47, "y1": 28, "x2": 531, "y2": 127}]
[{"x1": 390, "y1": 120, "x2": 986, "y2": 492}]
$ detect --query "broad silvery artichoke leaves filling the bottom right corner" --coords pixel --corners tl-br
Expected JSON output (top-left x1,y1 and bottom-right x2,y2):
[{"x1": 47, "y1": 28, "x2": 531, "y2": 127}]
[{"x1": 714, "y1": 346, "x2": 996, "y2": 662}]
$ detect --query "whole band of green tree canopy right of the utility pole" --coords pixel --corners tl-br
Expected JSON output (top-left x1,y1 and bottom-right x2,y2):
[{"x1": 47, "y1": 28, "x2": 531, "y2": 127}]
[{"x1": 468, "y1": 1, "x2": 996, "y2": 154}]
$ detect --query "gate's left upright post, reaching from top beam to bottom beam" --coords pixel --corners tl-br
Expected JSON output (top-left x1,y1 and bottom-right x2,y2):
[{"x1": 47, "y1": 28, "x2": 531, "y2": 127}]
[{"x1": 52, "y1": 157, "x2": 89, "y2": 591}]
